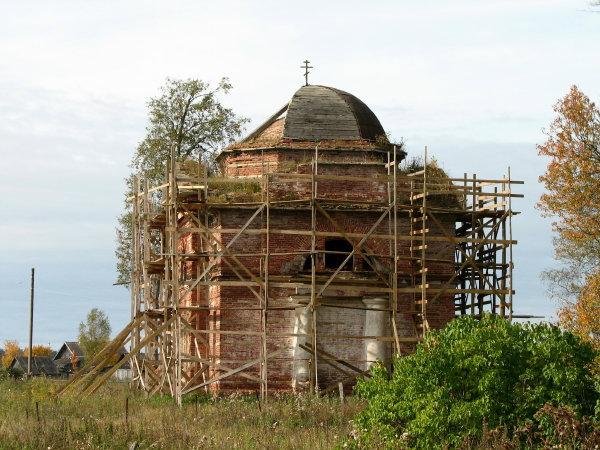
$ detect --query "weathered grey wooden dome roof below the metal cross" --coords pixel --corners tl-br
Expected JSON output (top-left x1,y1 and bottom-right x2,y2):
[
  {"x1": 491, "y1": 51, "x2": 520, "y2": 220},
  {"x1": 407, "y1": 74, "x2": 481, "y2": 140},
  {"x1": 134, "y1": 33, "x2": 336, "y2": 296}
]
[{"x1": 228, "y1": 85, "x2": 385, "y2": 150}]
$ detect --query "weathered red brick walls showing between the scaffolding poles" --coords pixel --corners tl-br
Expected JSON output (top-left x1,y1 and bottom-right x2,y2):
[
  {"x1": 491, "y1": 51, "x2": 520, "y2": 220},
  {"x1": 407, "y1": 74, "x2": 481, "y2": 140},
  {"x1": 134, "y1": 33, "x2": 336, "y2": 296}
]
[{"x1": 180, "y1": 145, "x2": 454, "y2": 391}]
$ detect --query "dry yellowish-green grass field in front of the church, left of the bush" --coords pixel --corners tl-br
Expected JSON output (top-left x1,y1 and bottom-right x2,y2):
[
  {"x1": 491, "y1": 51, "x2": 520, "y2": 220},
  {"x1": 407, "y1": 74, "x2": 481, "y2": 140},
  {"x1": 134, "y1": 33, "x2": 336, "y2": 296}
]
[{"x1": 0, "y1": 379, "x2": 361, "y2": 449}]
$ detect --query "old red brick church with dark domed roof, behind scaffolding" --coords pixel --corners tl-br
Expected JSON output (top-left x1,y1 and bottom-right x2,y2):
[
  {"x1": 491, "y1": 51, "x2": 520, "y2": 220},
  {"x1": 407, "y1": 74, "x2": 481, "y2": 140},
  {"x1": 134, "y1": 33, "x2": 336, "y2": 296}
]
[{"x1": 180, "y1": 85, "x2": 454, "y2": 391}]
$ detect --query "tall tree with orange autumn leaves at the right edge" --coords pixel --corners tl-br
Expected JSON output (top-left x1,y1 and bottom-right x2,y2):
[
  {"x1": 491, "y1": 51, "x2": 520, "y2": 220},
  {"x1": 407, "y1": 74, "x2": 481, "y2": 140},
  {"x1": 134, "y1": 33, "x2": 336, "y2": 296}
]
[{"x1": 538, "y1": 86, "x2": 600, "y2": 346}]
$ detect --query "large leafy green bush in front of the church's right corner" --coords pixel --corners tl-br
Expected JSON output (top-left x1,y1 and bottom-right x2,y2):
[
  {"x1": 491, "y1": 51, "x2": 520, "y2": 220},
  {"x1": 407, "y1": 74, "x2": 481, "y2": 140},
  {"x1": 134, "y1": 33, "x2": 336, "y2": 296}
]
[{"x1": 355, "y1": 316, "x2": 599, "y2": 448}]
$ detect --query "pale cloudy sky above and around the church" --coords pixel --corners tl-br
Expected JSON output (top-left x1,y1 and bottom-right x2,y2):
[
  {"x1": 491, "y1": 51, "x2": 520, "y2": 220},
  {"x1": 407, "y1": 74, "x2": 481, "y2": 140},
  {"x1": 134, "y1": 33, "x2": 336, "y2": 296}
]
[{"x1": 0, "y1": 0, "x2": 600, "y2": 346}]
